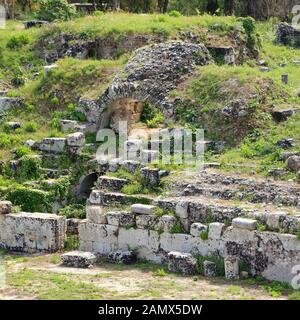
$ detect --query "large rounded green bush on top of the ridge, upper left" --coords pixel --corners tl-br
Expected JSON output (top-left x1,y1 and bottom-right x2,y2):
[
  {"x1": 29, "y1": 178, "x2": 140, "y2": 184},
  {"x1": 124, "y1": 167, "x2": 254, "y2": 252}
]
[{"x1": 36, "y1": 0, "x2": 76, "y2": 21}]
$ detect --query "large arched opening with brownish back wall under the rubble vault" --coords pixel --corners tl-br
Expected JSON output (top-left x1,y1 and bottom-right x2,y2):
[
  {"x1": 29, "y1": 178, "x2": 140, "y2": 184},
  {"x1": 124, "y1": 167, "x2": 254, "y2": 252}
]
[{"x1": 100, "y1": 98, "x2": 144, "y2": 132}]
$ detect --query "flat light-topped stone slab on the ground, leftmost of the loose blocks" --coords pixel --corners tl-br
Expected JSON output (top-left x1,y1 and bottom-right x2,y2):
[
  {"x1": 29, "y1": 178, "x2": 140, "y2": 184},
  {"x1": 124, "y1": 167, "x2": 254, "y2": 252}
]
[{"x1": 61, "y1": 251, "x2": 97, "y2": 268}]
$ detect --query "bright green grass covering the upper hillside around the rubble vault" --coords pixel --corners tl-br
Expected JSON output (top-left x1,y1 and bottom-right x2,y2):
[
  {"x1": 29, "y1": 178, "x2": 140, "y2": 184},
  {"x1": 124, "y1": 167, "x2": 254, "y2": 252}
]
[{"x1": 0, "y1": 13, "x2": 300, "y2": 180}]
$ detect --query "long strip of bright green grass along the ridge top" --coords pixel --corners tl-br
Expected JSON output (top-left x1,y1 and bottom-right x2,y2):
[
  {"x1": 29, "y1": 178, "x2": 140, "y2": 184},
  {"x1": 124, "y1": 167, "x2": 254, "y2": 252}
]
[{"x1": 41, "y1": 13, "x2": 241, "y2": 37}]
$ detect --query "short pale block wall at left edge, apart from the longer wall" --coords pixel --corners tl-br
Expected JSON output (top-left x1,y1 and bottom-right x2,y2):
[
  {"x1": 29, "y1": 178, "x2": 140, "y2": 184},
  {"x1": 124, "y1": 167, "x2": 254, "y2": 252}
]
[{"x1": 0, "y1": 212, "x2": 67, "y2": 253}]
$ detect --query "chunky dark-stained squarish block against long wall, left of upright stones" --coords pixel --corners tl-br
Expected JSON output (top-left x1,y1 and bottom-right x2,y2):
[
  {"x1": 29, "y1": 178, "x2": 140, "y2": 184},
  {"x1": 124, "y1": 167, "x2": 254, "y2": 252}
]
[{"x1": 168, "y1": 251, "x2": 197, "y2": 275}]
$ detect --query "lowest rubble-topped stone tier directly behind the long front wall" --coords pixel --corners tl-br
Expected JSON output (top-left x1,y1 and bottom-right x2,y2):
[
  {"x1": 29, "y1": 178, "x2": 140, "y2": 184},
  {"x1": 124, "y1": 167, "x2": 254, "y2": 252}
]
[{"x1": 153, "y1": 196, "x2": 300, "y2": 234}]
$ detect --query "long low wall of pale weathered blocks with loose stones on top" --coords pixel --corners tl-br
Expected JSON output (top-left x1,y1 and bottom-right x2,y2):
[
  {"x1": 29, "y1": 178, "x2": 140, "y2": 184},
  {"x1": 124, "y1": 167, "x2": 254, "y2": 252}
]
[{"x1": 79, "y1": 204, "x2": 300, "y2": 282}]
